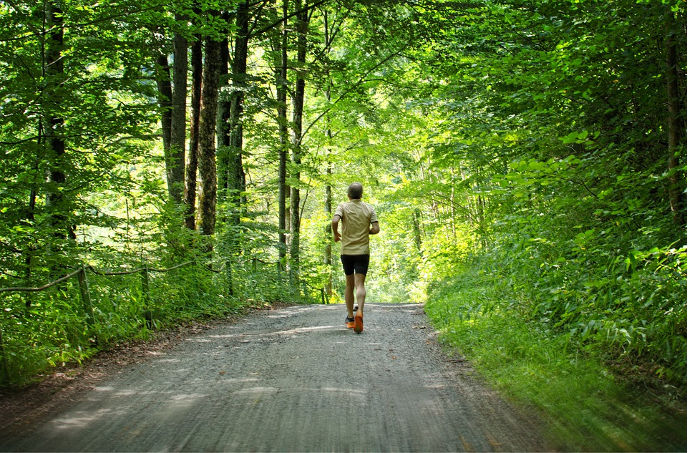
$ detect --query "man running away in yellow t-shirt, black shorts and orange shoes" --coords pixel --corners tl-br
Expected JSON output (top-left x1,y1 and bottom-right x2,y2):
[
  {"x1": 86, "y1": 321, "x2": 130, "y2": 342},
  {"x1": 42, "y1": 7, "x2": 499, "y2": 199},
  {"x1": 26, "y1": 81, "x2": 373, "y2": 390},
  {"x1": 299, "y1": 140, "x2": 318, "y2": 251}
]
[{"x1": 332, "y1": 182, "x2": 380, "y2": 333}]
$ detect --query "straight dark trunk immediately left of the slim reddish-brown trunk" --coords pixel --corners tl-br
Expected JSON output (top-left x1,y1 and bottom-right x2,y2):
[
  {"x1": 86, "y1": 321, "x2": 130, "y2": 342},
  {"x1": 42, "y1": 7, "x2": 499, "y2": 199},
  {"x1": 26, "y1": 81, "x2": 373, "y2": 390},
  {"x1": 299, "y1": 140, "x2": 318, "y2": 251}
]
[{"x1": 167, "y1": 25, "x2": 189, "y2": 206}]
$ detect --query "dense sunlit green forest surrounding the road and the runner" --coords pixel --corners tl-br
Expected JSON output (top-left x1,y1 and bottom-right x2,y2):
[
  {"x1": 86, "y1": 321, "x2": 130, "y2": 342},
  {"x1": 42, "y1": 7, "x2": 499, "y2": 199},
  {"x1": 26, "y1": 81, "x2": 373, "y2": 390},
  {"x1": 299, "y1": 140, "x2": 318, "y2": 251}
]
[{"x1": 0, "y1": 0, "x2": 686, "y2": 442}]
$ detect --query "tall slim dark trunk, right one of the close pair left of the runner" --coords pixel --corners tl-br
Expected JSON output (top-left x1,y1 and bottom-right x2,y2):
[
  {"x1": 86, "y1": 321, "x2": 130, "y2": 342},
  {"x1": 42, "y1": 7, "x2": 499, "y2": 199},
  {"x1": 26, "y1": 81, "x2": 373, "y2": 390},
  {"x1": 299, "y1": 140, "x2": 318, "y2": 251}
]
[{"x1": 290, "y1": 0, "x2": 308, "y2": 284}]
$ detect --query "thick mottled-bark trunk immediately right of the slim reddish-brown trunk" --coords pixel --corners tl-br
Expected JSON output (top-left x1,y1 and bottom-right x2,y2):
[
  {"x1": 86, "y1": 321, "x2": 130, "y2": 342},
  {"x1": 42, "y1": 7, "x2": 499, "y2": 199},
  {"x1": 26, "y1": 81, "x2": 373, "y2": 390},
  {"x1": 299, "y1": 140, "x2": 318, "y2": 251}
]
[{"x1": 198, "y1": 38, "x2": 220, "y2": 235}]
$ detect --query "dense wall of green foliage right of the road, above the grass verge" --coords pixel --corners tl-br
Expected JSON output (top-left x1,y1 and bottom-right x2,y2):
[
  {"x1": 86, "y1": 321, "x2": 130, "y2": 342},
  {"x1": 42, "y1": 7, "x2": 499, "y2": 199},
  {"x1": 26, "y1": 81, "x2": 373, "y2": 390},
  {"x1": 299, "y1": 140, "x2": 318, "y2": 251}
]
[{"x1": 388, "y1": 1, "x2": 686, "y2": 387}]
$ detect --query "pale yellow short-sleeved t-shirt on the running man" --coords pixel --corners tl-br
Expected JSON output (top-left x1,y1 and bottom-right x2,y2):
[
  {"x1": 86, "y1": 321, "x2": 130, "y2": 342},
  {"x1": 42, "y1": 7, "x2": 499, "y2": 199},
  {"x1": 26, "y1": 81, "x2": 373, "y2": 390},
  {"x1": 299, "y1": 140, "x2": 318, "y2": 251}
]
[{"x1": 334, "y1": 199, "x2": 377, "y2": 255}]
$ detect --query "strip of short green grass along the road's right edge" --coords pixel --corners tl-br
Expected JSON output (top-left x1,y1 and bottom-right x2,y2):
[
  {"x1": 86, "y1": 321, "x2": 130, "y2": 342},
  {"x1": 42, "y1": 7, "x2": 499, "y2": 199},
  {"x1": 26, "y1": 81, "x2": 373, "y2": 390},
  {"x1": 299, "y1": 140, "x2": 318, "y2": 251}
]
[{"x1": 425, "y1": 270, "x2": 686, "y2": 451}]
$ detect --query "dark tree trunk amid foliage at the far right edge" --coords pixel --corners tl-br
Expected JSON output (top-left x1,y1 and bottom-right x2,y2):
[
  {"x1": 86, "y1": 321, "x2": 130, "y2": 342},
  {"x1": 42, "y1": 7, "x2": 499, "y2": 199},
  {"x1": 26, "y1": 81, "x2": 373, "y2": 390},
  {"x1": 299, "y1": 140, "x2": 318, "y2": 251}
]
[{"x1": 664, "y1": 11, "x2": 685, "y2": 225}]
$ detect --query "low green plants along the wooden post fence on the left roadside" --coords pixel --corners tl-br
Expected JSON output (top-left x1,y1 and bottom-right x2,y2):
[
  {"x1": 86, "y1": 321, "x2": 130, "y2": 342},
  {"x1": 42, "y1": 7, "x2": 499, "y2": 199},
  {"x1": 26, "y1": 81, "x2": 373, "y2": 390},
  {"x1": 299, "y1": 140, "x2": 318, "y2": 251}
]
[{"x1": 0, "y1": 262, "x2": 232, "y2": 385}]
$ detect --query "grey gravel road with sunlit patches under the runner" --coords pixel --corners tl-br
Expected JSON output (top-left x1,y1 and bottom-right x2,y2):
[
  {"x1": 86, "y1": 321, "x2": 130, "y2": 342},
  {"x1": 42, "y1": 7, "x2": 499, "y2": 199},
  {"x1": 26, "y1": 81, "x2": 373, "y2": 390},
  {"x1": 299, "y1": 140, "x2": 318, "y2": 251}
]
[{"x1": 0, "y1": 304, "x2": 549, "y2": 451}]
